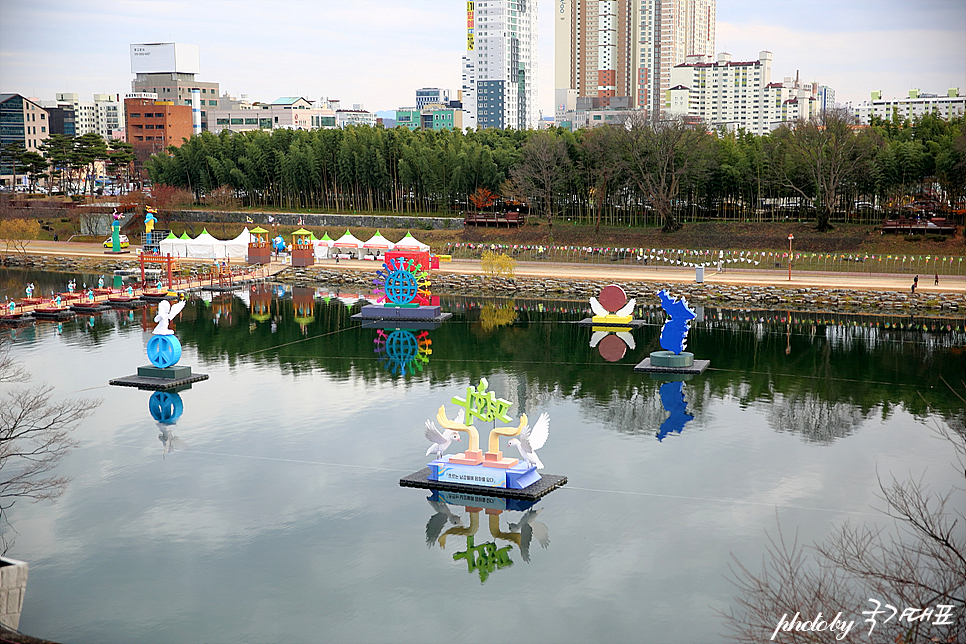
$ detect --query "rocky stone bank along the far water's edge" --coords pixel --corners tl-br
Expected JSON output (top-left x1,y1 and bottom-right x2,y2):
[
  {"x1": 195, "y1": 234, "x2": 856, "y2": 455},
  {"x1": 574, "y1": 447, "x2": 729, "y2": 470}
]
[{"x1": 5, "y1": 255, "x2": 966, "y2": 317}]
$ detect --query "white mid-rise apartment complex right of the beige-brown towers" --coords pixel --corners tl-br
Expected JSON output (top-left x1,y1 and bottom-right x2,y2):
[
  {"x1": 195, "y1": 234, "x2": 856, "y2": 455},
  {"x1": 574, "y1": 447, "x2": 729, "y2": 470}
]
[{"x1": 664, "y1": 51, "x2": 835, "y2": 134}]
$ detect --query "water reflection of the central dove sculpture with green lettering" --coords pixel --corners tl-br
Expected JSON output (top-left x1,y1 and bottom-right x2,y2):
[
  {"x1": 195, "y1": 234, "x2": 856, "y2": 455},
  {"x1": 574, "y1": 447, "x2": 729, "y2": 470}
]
[{"x1": 426, "y1": 490, "x2": 550, "y2": 583}]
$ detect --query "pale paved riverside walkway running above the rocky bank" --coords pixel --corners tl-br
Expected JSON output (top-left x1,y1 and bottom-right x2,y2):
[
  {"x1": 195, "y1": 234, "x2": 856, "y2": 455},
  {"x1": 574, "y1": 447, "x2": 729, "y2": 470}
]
[{"x1": 15, "y1": 241, "x2": 966, "y2": 296}]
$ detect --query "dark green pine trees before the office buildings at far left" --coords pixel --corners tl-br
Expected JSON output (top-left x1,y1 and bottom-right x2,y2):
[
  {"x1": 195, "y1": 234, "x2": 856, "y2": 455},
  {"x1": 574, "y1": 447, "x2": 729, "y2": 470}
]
[{"x1": 0, "y1": 132, "x2": 134, "y2": 195}]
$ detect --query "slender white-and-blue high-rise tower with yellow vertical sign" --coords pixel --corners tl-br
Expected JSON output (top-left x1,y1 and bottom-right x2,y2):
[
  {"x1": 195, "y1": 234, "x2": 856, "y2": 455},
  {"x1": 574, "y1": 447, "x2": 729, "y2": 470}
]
[{"x1": 462, "y1": 0, "x2": 539, "y2": 130}]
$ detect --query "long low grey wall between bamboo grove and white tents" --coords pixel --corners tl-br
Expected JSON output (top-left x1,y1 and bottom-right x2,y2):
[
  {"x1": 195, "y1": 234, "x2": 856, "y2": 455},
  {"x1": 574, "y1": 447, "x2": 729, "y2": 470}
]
[{"x1": 165, "y1": 210, "x2": 463, "y2": 230}]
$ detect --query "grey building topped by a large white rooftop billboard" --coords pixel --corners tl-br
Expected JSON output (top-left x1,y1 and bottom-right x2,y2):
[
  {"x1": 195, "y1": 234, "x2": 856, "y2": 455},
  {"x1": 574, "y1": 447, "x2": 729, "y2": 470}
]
[{"x1": 131, "y1": 43, "x2": 219, "y2": 130}]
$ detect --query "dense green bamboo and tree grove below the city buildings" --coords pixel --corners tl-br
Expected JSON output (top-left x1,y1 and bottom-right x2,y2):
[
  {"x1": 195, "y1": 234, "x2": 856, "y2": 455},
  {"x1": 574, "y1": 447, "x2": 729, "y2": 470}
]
[{"x1": 145, "y1": 112, "x2": 966, "y2": 229}]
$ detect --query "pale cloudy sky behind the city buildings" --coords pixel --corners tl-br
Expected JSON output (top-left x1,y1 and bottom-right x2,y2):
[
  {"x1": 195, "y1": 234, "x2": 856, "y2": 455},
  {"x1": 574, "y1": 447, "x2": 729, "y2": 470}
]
[{"x1": 0, "y1": 0, "x2": 966, "y2": 115}]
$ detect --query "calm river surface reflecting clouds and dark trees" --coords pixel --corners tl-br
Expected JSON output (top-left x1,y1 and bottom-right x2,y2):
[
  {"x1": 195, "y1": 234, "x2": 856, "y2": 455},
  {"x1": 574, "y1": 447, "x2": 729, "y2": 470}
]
[{"x1": 4, "y1": 277, "x2": 966, "y2": 644}]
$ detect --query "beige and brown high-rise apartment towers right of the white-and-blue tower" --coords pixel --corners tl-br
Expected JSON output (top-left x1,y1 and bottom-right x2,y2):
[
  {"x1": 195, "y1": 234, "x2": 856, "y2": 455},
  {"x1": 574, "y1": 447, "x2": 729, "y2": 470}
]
[{"x1": 554, "y1": 0, "x2": 716, "y2": 116}]
